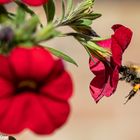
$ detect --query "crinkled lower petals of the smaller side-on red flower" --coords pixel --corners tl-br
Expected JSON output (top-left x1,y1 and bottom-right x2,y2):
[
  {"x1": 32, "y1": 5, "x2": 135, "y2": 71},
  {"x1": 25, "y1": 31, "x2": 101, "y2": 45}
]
[{"x1": 89, "y1": 58, "x2": 113, "y2": 103}]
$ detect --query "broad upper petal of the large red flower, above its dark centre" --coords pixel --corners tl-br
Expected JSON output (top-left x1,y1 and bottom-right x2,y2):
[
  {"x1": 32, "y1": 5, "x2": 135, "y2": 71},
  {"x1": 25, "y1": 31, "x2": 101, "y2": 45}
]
[{"x1": 9, "y1": 47, "x2": 54, "y2": 81}]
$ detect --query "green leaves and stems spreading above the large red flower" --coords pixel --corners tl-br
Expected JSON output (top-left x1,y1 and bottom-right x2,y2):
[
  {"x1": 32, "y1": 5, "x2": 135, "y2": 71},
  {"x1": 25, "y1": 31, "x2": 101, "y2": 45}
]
[{"x1": 0, "y1": 0, "x2": 111, "y2": 66}]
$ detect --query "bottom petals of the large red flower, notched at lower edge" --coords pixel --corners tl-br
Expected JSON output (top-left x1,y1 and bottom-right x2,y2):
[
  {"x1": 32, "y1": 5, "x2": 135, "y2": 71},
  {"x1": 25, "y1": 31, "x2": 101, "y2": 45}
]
[{"x1": 0, "y1": 93, "x2": 55, "y2": 134}]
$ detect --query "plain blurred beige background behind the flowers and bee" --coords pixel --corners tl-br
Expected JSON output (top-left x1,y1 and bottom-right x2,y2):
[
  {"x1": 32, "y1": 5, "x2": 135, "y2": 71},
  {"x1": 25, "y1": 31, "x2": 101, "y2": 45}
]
[{"x1": 11, "y1": 0, "x2": 140, "y2": 140}]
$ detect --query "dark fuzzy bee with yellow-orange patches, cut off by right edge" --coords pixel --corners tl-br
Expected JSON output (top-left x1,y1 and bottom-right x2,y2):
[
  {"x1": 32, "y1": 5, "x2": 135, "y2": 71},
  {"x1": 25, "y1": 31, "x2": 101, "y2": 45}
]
[{"x1": 120, "y1": 64, "x2": 140, "y2": 104}]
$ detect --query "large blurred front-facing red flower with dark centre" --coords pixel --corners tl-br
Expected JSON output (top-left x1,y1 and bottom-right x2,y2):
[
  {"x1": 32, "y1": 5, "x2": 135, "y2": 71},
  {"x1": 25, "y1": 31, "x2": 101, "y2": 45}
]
[{"x1": 0, "y1": 47, "x2": 72, "y2": 134}]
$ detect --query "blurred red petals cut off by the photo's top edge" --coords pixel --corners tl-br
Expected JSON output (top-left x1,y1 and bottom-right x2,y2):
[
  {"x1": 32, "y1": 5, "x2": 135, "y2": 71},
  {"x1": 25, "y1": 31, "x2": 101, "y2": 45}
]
[{"x1": 0, "y1": 0, "x2": 48, "y2": 6}]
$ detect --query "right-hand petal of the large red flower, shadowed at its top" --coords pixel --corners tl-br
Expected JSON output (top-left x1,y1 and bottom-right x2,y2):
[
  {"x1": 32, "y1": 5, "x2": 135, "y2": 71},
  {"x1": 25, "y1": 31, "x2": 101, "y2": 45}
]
[{"x1": 40, "y1": 60, "x2": 73, "y2": 100}]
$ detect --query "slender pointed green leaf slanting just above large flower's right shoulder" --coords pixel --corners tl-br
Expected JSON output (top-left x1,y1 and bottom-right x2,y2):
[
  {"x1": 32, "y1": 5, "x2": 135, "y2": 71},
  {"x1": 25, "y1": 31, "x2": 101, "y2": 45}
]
[{"x1": 47, "y1": 47, "x2": 78, "y2": 66}]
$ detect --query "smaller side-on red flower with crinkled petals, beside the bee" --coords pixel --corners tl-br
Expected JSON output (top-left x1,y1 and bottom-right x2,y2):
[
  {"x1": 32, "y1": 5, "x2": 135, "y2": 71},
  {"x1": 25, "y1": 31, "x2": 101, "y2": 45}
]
[{"x1": 89, "y1": 25, "x2": 132, "y2": 102}]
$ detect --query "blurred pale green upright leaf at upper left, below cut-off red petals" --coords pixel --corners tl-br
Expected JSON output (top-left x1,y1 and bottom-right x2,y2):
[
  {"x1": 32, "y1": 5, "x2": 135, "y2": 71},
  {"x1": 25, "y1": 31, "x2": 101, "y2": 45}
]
[{"x1": 15, "y1": 6, "x2": 26, "y2": 25}]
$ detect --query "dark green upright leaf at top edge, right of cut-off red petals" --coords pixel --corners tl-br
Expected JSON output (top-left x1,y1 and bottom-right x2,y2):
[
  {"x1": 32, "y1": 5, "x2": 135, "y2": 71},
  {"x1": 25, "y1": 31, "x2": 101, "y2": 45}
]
[{"x1": 43, "y1": 0, "x2": 55, "y2": 23}]
